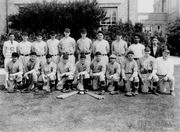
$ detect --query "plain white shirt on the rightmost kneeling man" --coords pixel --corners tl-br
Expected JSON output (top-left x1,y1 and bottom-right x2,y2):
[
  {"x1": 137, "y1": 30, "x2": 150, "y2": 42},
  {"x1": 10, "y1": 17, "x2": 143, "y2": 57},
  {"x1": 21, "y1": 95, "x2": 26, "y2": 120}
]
[{"x1": 156, "y1": 57, "x2": 174, "y2": 77}]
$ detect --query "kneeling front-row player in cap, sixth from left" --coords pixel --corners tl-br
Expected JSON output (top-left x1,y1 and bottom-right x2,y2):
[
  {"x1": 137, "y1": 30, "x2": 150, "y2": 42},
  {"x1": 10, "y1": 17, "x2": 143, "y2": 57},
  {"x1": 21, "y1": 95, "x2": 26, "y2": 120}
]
[{"x1": 90, "y1": 52, "x2": 106, "y2": 95}]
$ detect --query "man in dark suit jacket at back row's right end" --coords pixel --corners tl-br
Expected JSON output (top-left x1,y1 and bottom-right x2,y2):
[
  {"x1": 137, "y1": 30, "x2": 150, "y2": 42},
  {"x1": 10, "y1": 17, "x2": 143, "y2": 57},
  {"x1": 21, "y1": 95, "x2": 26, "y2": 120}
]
[{"x1": 150, "y1": 37, "x2": 162, "y2": 58}]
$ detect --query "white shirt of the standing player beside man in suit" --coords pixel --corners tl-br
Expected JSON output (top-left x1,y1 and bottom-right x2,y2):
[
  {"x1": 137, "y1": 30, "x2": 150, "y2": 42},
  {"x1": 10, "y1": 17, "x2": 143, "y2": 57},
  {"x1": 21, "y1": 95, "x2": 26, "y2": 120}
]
[{"x1": 129, "y1": 43, "x2": 145, "y2": 58}]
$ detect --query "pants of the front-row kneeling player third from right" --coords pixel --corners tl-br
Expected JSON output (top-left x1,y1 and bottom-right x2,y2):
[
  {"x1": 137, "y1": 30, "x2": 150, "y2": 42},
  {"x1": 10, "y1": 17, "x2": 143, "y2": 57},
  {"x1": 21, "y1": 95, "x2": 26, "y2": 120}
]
[{"x1": 125, "y1": 74, "x2": 139, "y2": 92}]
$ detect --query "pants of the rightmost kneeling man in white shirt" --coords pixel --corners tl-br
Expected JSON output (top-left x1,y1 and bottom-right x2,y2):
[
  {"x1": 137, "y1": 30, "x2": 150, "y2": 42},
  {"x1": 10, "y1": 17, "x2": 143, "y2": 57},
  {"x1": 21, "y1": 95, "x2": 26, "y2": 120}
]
[{"x1": 158, "y1": 75, "x2": 175, "y2": 93}]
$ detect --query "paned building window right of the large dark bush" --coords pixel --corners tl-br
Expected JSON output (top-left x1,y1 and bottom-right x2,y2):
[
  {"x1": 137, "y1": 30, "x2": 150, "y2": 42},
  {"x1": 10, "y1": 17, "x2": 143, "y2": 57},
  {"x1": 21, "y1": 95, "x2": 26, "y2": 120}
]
[{"x1": 101, "y1": 7, "x2": 118, "y2": 29}]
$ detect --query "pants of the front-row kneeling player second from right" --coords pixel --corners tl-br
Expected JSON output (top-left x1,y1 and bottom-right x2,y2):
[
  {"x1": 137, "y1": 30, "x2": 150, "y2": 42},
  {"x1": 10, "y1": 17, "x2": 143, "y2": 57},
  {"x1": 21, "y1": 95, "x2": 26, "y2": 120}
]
[{"x1": 141, "y1": 73, "x2": 159, "y2": 93}]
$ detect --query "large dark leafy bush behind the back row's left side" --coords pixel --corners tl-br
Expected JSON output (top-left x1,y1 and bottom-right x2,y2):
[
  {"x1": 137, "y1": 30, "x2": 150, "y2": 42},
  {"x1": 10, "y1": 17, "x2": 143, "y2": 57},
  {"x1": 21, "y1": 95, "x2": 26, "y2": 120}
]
[{"x1": 8, "y1": 0, "x2": 106, "y2": 39}]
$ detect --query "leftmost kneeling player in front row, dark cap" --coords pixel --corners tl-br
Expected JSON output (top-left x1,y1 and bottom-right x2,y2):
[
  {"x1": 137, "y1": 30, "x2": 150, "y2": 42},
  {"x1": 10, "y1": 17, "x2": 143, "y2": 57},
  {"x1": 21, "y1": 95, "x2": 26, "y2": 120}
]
[{"x1": 6, "y1": 52, "x2": 23, "y2": 93}]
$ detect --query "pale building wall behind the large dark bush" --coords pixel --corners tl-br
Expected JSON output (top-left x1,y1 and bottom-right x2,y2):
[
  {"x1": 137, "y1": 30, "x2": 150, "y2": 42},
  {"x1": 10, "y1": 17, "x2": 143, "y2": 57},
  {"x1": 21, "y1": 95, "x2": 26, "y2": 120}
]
[{"x1": 0, "y1": 0, "x2": 138, "y2": 34}]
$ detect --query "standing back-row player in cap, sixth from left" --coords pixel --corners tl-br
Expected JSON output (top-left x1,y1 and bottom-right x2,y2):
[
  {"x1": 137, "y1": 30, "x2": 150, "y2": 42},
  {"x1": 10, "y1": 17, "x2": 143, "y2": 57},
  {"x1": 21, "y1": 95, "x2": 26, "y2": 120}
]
[{"x1": 77, "y1": 29, "x2": 92, "y2": 62}]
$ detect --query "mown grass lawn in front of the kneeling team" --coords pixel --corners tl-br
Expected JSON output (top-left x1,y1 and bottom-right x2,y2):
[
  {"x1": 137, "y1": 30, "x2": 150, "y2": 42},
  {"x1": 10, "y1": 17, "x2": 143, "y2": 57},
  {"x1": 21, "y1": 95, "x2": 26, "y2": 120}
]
[{"x1": 0, "y1": 66, "x2": 180, "y2": 132}]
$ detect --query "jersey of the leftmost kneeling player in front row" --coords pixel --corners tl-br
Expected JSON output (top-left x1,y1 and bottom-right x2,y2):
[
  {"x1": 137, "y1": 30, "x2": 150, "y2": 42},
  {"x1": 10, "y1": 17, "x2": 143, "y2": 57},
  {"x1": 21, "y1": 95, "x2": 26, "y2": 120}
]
[{"x1": 6, "y1": 60, "x2": 23, "y2": 74}]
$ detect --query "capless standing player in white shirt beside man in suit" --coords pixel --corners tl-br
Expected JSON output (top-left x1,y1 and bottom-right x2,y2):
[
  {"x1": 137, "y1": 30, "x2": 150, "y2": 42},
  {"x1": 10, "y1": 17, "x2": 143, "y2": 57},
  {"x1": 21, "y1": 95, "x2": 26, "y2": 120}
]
[{"x1": 128, "y1": 35, "x2": 145, "y2": 60}]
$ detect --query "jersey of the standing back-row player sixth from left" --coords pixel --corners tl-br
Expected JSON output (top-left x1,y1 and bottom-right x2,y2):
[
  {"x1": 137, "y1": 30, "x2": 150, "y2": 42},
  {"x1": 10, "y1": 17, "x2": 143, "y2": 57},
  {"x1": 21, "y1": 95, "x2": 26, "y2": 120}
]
[{"x1": 77, "y1": 37, "x2": 92, "y2": 53}]
